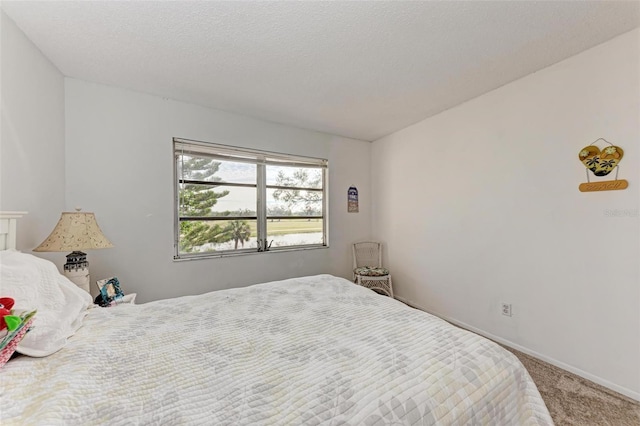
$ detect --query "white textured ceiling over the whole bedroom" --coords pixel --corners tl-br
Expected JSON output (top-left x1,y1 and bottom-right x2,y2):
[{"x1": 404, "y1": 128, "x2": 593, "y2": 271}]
[{"x1": 1, "y1": 1, "x2": 640, "y2": 140}]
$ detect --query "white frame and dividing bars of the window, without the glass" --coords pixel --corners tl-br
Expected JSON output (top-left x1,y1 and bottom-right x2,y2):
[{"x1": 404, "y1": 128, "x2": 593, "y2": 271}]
[{"x1": 173, "y1": 138, "x2": 329, "y2": 260}]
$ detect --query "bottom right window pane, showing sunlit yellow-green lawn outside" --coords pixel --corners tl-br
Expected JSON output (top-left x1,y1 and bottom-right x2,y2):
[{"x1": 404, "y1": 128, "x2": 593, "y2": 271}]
[{"x1": 267, "y1": 219, "x2": 323, "y2": 249}]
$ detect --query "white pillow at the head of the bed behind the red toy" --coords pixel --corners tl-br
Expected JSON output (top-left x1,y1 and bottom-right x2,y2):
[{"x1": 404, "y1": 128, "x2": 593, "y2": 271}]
[{"x1": 0, "y1": 250, "x2": 93, "y2": 357}]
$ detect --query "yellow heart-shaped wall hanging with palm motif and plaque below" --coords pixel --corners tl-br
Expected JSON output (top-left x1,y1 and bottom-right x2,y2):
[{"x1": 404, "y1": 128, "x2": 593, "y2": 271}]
[{"x1": 578, "y1": 138, "x2": 629, "y2": 192}]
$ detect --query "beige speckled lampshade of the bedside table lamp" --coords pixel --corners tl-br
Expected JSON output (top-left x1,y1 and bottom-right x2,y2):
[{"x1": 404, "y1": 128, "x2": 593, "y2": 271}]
[{"x1": 33, "y1": 212, "x2": 113, "y2": 251}]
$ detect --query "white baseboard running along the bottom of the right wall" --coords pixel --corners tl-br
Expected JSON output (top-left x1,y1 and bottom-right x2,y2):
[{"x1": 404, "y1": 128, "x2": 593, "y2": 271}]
[{"x1": 395, "y1": 296, "x2": 640, "y2": 401}]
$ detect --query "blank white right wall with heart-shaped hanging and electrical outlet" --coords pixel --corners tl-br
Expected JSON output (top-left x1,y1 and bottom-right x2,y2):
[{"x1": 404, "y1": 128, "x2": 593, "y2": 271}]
[{"x1": 372, "y1": 30, "x2": 640, "y2": 399}]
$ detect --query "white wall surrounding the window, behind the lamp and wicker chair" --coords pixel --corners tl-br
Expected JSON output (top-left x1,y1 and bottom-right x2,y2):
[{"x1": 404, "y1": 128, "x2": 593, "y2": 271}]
[{"x1": 65, "y1": 78, "x2": 371, "y2": 301}]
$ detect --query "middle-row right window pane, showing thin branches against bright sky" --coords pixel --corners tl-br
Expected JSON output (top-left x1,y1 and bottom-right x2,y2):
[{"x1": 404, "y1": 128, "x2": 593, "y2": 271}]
[{"x1": 267, "y1": 188, "x2": 322, "y2": 217}]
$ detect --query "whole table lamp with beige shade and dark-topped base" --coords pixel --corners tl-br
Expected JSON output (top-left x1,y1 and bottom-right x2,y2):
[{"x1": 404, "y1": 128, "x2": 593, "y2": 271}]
[{"x1": 33, "y1": 209, "x2": 113, "y2": 292}]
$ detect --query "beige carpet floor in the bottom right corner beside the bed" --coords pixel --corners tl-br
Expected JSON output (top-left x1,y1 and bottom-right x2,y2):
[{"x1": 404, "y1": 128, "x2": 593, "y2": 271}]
[{"x1": 505, "y1": 347, "x2": 640, "y2": 426}]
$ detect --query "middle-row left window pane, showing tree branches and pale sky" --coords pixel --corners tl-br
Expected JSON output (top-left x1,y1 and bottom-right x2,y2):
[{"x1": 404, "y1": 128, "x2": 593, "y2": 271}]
[{"x1": 180, "y1": 184, "x2": 257, "y2": 217}]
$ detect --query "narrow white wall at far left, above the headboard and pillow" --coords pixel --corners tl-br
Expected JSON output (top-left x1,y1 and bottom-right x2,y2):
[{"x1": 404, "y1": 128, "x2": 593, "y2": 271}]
[{"x1": 0, "y1": 11, "x2": 65, "y2": 260}]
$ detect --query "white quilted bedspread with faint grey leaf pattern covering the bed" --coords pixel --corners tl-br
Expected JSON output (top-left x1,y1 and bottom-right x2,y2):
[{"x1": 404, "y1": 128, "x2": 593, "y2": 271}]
[{"x1": 0, "y1": 275, "x2": 553, "y2": 425}]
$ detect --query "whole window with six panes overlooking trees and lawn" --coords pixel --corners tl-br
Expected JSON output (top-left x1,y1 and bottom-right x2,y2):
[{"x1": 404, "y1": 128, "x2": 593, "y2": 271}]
[{"x1": 173, "y1": 138, "x2": 328, "y2": 259}]
